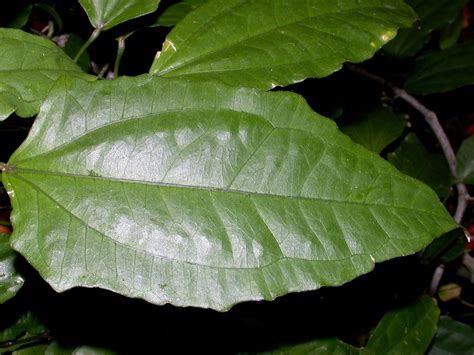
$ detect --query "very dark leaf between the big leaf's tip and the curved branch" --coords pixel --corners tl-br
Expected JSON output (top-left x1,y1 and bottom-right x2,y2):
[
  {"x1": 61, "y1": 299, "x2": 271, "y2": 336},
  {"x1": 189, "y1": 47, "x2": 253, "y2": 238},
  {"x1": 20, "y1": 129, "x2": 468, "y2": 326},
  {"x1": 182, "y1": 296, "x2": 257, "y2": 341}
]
[{"x1": 388, "y1": 133, "x2": 452, "y2": 197}]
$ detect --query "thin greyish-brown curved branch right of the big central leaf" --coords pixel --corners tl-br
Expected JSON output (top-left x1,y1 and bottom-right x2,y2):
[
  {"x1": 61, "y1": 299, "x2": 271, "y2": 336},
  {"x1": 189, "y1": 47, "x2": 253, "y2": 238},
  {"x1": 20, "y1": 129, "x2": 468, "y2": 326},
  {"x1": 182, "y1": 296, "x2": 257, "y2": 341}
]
[{"x1": 346, "y1": 63, "x2": 473, "y2": 224}]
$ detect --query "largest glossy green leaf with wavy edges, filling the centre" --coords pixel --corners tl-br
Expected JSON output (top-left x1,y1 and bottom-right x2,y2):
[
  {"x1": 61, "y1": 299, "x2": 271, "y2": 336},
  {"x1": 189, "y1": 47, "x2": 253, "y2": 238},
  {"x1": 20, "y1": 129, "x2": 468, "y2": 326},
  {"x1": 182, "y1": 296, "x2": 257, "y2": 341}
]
[{"x1": 3, "y1": 76, "x2": 456, "y2": 310}]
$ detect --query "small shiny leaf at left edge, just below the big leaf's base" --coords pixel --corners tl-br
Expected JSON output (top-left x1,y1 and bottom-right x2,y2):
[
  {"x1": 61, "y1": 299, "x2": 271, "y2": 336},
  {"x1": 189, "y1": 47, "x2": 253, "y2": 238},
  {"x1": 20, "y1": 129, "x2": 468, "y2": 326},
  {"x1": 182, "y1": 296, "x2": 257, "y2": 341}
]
[{"x1": 0, "y1": 233, "x2": 25, "y2": 304}]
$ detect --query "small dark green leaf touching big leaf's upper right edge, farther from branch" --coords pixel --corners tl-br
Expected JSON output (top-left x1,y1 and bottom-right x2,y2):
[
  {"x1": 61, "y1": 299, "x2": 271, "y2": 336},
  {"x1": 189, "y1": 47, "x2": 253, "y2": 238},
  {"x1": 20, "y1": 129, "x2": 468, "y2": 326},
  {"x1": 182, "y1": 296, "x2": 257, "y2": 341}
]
[{"x1": 341, "y1": 107, "x2": 405, "y2": 154}]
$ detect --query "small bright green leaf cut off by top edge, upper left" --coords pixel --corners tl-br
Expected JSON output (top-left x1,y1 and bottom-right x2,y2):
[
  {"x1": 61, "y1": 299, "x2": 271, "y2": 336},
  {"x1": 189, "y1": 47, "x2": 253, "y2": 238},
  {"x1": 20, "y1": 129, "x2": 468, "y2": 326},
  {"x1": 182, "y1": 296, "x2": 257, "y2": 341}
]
[{"x1": 79, "y1": 0, "x2": 160, "y2": 30}]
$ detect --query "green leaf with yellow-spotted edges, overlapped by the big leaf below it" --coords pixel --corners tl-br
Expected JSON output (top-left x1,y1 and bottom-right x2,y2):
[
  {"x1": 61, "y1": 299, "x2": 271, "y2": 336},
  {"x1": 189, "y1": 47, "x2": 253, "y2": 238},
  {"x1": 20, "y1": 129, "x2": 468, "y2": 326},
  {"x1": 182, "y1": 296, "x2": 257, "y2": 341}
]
[{"x1": 150, "y1": 0, "x2": 415, "y2": 89}]
